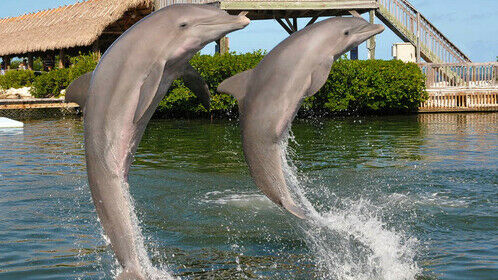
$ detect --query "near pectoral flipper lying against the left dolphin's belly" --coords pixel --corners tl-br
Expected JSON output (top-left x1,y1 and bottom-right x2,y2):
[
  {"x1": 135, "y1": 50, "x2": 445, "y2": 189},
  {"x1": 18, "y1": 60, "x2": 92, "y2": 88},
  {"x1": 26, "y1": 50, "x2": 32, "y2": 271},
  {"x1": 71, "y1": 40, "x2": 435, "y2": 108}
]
[{"x1": 133, "y1": 63, "x2": 164, "y2": 123}]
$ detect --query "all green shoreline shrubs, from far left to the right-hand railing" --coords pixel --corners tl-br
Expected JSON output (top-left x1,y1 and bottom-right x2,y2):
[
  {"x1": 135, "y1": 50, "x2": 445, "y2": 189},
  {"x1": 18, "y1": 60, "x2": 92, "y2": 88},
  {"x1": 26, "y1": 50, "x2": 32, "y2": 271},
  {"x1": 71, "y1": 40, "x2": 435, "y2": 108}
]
[{"x1": 0, "y1": 51, "x2": 427, "y2": 118}]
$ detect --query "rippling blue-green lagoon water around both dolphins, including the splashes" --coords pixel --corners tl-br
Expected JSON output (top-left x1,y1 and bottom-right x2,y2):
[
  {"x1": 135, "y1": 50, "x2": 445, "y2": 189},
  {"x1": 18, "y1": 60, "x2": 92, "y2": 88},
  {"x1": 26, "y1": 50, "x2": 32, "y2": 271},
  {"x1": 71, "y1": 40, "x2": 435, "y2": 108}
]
[{"x1": 0, "y1": 113, "x2": 498, "y2": 279}]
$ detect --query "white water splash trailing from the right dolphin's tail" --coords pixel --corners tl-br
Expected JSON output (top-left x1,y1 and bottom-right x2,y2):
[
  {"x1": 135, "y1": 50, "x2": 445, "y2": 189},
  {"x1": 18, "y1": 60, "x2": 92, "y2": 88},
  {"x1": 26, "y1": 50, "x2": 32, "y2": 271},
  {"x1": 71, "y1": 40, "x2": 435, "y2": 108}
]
[{"x1": 281, "y1": 130, "x2": 421, "y2": 280}]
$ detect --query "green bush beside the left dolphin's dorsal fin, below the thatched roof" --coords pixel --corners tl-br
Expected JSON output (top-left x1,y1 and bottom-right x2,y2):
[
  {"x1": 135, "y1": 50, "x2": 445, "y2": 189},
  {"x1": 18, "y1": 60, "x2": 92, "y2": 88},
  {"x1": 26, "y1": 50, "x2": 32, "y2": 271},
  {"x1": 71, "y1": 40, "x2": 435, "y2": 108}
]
[{"x1": 31, "y1": 54, "x2": 98, "y2": 98}]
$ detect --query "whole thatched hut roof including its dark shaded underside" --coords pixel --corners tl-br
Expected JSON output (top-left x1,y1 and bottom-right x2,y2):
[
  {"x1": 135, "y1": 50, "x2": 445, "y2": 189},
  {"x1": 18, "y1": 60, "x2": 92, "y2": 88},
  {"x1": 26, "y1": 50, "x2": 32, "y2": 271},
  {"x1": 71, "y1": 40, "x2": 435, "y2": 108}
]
[{"x1": 0, "y1": 0, "x2": 154, "y2": 68}]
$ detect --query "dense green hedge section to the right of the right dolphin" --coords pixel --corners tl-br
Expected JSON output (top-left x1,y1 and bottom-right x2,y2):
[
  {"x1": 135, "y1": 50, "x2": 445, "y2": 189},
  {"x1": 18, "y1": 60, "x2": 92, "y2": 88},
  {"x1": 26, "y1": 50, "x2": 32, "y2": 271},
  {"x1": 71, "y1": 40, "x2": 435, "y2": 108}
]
[{"x1": 310, "y1": 60, "x2": 427, "y2": 113}]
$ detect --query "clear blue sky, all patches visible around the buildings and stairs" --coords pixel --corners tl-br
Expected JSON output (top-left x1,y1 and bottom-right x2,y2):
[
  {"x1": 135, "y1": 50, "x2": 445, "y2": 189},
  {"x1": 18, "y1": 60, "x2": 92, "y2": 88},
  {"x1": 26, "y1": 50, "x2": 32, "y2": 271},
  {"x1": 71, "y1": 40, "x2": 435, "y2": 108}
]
[{"x1": 0, "y1": 0, "x2": 498, "y2": 62}]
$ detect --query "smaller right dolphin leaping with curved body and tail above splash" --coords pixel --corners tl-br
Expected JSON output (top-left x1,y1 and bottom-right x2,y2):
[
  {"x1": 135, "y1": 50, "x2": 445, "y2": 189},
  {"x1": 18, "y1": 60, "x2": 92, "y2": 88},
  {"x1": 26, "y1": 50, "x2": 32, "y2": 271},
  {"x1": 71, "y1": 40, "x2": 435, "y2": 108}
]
[{"x1": 218, "y1": 18, "x2": 384, "y2": 218}]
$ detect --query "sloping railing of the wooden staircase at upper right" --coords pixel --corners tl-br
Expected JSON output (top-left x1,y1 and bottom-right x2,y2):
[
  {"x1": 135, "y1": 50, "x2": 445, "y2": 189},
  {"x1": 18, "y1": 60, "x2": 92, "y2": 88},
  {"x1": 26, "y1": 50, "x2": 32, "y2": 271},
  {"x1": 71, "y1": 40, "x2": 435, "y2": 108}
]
[{"x1": 377, "y1": 0, "x2": 471, "y2": 63}]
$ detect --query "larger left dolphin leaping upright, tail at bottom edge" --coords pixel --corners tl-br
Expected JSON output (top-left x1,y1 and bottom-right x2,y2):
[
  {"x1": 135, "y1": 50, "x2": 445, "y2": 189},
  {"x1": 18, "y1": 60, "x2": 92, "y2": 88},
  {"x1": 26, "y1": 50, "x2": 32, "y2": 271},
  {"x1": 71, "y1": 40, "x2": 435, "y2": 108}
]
[{"x1": 66, "y1": 4, "x2": 250, "y2": 279}]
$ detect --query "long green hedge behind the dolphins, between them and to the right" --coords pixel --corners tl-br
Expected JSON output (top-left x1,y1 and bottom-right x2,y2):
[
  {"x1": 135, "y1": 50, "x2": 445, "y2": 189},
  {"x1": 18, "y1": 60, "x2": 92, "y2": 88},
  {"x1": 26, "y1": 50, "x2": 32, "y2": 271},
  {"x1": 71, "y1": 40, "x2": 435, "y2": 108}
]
[{"x1": 158, "y1": 51, "x2": 427, "y2": 116}]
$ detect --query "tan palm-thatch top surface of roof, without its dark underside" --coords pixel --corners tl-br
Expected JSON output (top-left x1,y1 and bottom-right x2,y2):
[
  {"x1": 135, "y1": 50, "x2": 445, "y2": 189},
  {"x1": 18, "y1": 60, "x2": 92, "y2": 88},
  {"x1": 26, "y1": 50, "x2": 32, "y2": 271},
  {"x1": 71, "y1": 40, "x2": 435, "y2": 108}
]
[{"x1": 0, "y1": 0, "x2": 153, "y2": 56}]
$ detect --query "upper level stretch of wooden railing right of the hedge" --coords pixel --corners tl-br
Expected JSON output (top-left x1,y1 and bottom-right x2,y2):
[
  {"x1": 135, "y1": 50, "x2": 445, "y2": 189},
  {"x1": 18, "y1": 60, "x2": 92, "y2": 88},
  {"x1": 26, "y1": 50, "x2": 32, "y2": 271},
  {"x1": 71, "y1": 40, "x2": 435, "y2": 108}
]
[{"x1": 419, "y1": 62, "x2": 498, "y2": 89}]
